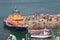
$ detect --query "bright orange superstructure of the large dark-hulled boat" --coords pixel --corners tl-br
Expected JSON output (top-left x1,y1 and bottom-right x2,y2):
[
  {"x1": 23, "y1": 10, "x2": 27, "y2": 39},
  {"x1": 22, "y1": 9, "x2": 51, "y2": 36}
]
[{"x1": 6, "y1": 13, "x2": 24, "y2": 25}]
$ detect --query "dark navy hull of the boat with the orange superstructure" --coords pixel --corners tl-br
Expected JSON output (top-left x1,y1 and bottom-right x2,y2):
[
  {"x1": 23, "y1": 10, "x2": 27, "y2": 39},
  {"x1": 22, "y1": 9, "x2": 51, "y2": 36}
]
[{"x1": 3, "y1": 21, "x2": 28, "y2": 33}]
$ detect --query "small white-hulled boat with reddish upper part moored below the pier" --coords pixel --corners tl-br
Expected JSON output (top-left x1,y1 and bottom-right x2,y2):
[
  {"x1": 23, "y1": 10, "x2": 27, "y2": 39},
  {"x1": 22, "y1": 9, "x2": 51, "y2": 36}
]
[{"x1": 31, "y1": 29, "x2": 52, "y2": 38}]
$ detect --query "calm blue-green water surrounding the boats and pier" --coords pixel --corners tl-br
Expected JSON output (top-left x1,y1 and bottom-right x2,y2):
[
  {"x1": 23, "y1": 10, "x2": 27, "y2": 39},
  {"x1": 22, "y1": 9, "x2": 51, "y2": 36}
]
[{"x1": 0, "y1": 0, "x2": 60, "y2": 40}]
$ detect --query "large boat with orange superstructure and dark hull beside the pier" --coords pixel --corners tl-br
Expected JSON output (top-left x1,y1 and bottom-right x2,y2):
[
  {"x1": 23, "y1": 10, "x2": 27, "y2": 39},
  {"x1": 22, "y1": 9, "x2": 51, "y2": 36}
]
[{"x1": 3, "y1": 9, "x2": 28, "y2": 32}]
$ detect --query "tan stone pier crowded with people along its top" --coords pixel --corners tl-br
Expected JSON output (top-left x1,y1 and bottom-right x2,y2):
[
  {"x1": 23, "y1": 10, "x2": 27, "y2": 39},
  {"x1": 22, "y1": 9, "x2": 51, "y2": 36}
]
[{"x1": 25, "y1": 14, "x2": 60, "y2": 29}]
